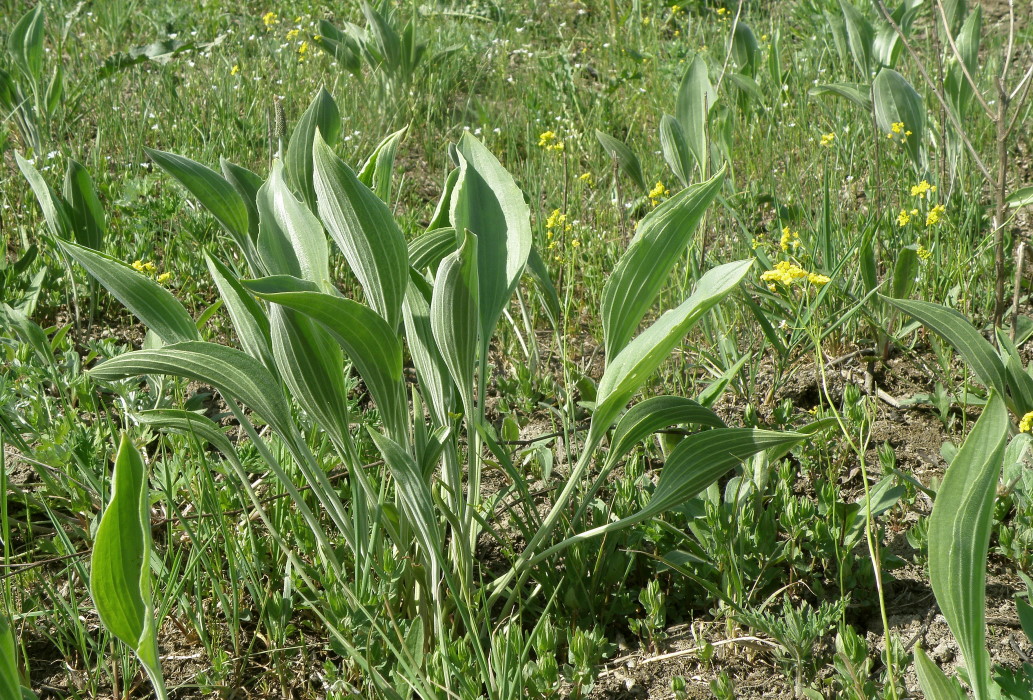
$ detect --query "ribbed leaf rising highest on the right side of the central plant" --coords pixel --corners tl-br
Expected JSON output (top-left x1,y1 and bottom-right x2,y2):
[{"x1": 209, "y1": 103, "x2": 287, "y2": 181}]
[{"x1": 601, "y1": 169, "x2": 724, "y2": 362}]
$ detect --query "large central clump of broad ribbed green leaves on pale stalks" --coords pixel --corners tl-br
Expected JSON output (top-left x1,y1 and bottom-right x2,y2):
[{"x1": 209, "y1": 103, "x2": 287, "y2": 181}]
[{"x1": 59, "y1": 91, "x2": 807, "y2": 700}]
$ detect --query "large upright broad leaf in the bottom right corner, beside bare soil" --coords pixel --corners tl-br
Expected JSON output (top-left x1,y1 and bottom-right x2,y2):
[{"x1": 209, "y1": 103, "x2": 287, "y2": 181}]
[{"x1": 929, "y1": 393, "x2": 1009, "y2": 700}]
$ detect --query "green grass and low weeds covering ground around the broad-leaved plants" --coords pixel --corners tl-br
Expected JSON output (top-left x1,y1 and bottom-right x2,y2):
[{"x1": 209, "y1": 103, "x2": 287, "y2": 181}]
[{"x1": 0, "y1": 0, "x2": 1033, "y2": 699}]
